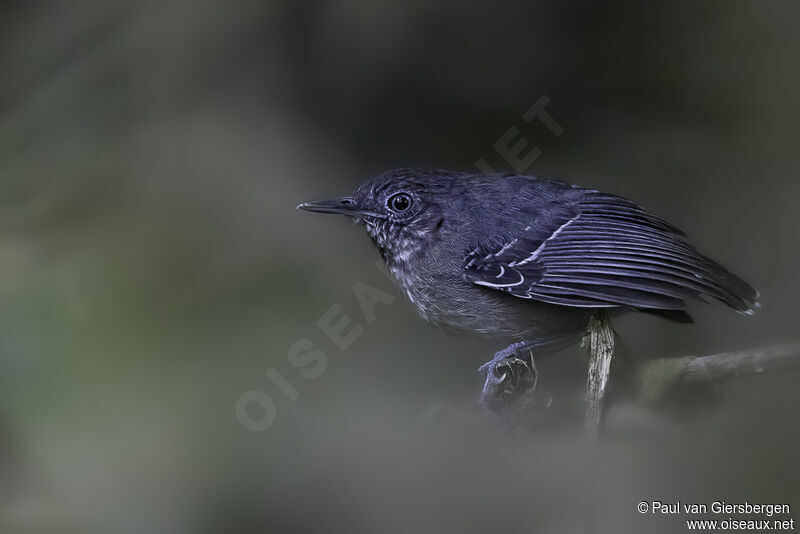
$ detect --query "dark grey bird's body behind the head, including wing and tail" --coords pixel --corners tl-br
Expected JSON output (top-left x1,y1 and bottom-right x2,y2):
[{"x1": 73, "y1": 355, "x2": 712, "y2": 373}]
[{"x1": 403, "y1": 175, "x2": 757, "y2": 344}]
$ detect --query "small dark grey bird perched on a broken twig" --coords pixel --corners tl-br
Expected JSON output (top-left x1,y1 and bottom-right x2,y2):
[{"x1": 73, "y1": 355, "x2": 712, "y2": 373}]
[{"x1": 298, "y1": 169, "x2": 758, "y2": 402}]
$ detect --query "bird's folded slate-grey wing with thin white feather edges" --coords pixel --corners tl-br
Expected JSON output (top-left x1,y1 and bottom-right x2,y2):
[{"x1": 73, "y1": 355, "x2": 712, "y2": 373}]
[{"x1": 464, "y1": 191, "x2": 757, "y2": 312}]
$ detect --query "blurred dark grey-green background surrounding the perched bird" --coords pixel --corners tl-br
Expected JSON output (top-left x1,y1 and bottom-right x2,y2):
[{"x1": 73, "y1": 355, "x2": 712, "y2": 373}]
[{"x1": 0, "y1": 0, "x2": 800, "y2": 533}]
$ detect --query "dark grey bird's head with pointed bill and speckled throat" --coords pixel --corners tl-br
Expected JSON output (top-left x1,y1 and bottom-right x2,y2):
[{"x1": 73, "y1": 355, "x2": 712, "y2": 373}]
[{"x1": 297, "y1": 169, "x2": 461, "y2": 265}]
